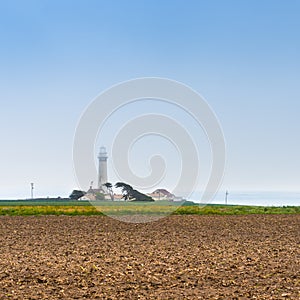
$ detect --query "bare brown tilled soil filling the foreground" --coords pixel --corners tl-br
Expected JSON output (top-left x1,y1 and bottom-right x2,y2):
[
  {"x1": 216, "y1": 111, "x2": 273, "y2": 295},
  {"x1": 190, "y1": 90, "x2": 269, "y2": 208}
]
[{"x1": 0, "y1": 215, "x2": 300, "y2": 299}]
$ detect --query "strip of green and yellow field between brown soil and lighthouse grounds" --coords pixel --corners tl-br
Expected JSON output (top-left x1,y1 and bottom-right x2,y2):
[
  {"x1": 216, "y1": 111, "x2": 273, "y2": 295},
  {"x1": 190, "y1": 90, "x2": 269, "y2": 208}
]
[{"x1": 0, "y1": 200, "x2": 300, "y2": 216}]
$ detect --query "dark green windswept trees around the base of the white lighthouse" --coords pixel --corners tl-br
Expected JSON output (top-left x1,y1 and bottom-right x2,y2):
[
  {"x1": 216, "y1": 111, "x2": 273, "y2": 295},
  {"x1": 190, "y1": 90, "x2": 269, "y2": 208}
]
[{"x1": 69, "y1": 182, "x2": 154, "y2": 202}]
